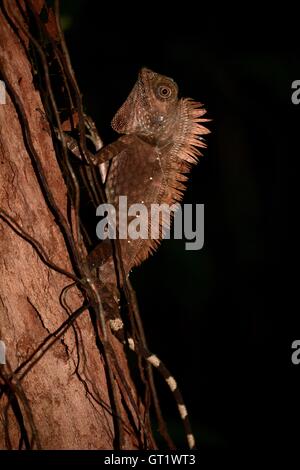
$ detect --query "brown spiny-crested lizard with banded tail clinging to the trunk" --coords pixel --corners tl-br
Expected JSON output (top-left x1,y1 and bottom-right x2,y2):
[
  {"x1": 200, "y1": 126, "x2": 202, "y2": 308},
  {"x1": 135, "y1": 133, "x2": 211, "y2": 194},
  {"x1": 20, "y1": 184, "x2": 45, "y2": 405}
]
[{"x1": 62, "y1": 68, "x2": 210, "y2": 449}]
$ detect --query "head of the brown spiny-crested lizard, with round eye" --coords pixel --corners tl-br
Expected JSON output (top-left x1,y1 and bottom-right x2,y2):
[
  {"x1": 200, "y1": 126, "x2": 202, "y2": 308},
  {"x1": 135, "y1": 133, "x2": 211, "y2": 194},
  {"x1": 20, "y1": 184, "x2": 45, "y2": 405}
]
[{"x1": 111, "y1": 68, "x2": 178, "y2": 142}]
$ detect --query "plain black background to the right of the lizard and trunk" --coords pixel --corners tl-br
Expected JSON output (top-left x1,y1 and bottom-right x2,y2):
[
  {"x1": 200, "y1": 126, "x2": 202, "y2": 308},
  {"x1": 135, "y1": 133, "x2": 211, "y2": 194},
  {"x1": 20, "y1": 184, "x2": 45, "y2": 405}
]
[{"x1": 62, "y1": 1, "x2": 300, "y2": 455}]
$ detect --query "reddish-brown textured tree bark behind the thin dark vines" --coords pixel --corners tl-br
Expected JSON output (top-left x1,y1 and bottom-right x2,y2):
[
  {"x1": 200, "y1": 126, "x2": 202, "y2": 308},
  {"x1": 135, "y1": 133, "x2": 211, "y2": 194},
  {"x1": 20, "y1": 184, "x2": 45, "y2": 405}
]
[{"x1": 0, "y1": 2, "x2": 141, "y2": 449}]
